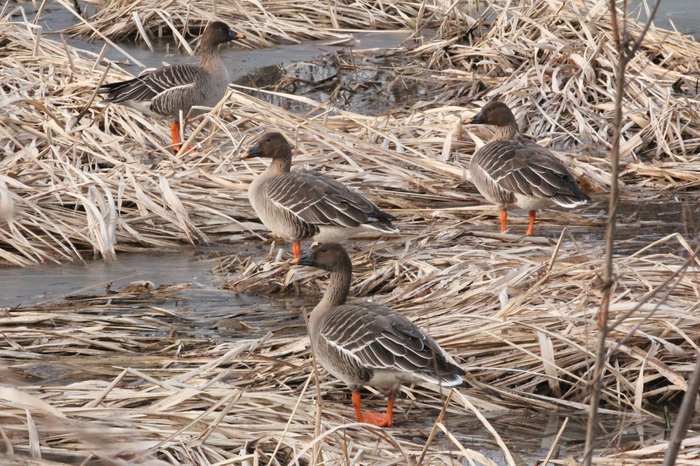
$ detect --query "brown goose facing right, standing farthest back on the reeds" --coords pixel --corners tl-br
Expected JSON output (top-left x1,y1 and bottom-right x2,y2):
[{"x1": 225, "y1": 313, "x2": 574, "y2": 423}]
[{"x1": 98, "y1": 21, "x2": 245, "y2": 152}]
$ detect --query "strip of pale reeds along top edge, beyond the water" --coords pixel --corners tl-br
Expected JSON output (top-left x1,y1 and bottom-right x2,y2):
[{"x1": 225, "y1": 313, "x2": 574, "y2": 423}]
[{"x1": 61, "y1": 0, "x2": 475, "y2": 46}]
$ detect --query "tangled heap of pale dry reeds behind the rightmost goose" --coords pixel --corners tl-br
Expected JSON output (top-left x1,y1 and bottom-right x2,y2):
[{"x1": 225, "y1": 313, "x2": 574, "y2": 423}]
[{"x1": 399, "y1": 0, "x2": 700, "y2": 164}]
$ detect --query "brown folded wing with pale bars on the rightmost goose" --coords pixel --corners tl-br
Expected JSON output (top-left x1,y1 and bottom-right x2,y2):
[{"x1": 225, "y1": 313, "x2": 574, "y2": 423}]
[{"x1": 475, "y1": 138, "x2": 590, "y2": 207}]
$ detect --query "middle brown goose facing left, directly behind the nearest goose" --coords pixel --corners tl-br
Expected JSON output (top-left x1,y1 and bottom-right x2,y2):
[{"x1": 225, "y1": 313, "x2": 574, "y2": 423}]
[{"x1": 241, "y1": 133, "x2": 399, "y2": 259}]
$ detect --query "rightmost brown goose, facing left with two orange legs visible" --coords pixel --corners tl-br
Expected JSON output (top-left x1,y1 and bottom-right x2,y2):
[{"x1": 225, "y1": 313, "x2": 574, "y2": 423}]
[{"x1": 464, "y1": 102, "x2": 591, "y2": 236}]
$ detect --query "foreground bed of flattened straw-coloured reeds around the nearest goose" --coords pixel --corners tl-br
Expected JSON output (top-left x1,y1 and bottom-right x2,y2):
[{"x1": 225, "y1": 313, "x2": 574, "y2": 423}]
[{"x1": 0, "y1": 232, "x2": 700, "y2": 465}]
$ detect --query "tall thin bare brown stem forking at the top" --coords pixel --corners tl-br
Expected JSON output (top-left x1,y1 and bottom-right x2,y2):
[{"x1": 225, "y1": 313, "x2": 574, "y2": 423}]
[{"x1": 583, "y1": 0, "x2": 661, "y2": 466}]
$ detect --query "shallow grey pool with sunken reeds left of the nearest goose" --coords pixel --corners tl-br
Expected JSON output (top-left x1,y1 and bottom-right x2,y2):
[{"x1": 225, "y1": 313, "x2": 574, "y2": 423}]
[{"x1": 0, "y1": 248, "x2": 313, "y2": 338}]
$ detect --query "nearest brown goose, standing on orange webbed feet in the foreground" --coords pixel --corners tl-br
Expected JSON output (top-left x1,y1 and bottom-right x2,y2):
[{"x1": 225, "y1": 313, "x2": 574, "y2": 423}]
[{"x1": 292, "y1": 243, "x2": 465, "y2": 427}]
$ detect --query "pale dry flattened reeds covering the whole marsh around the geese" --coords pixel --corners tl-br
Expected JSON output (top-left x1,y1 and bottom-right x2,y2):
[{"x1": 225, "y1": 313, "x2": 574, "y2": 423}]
[{"x1": 0, "y1": 0, "x2": 700, "y2": 465}]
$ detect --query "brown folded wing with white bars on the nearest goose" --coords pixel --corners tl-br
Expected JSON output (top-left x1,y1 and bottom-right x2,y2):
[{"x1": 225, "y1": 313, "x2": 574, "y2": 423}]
[{"x1": 320, "y1": 304, "x2": 465, "y2": 386}]
